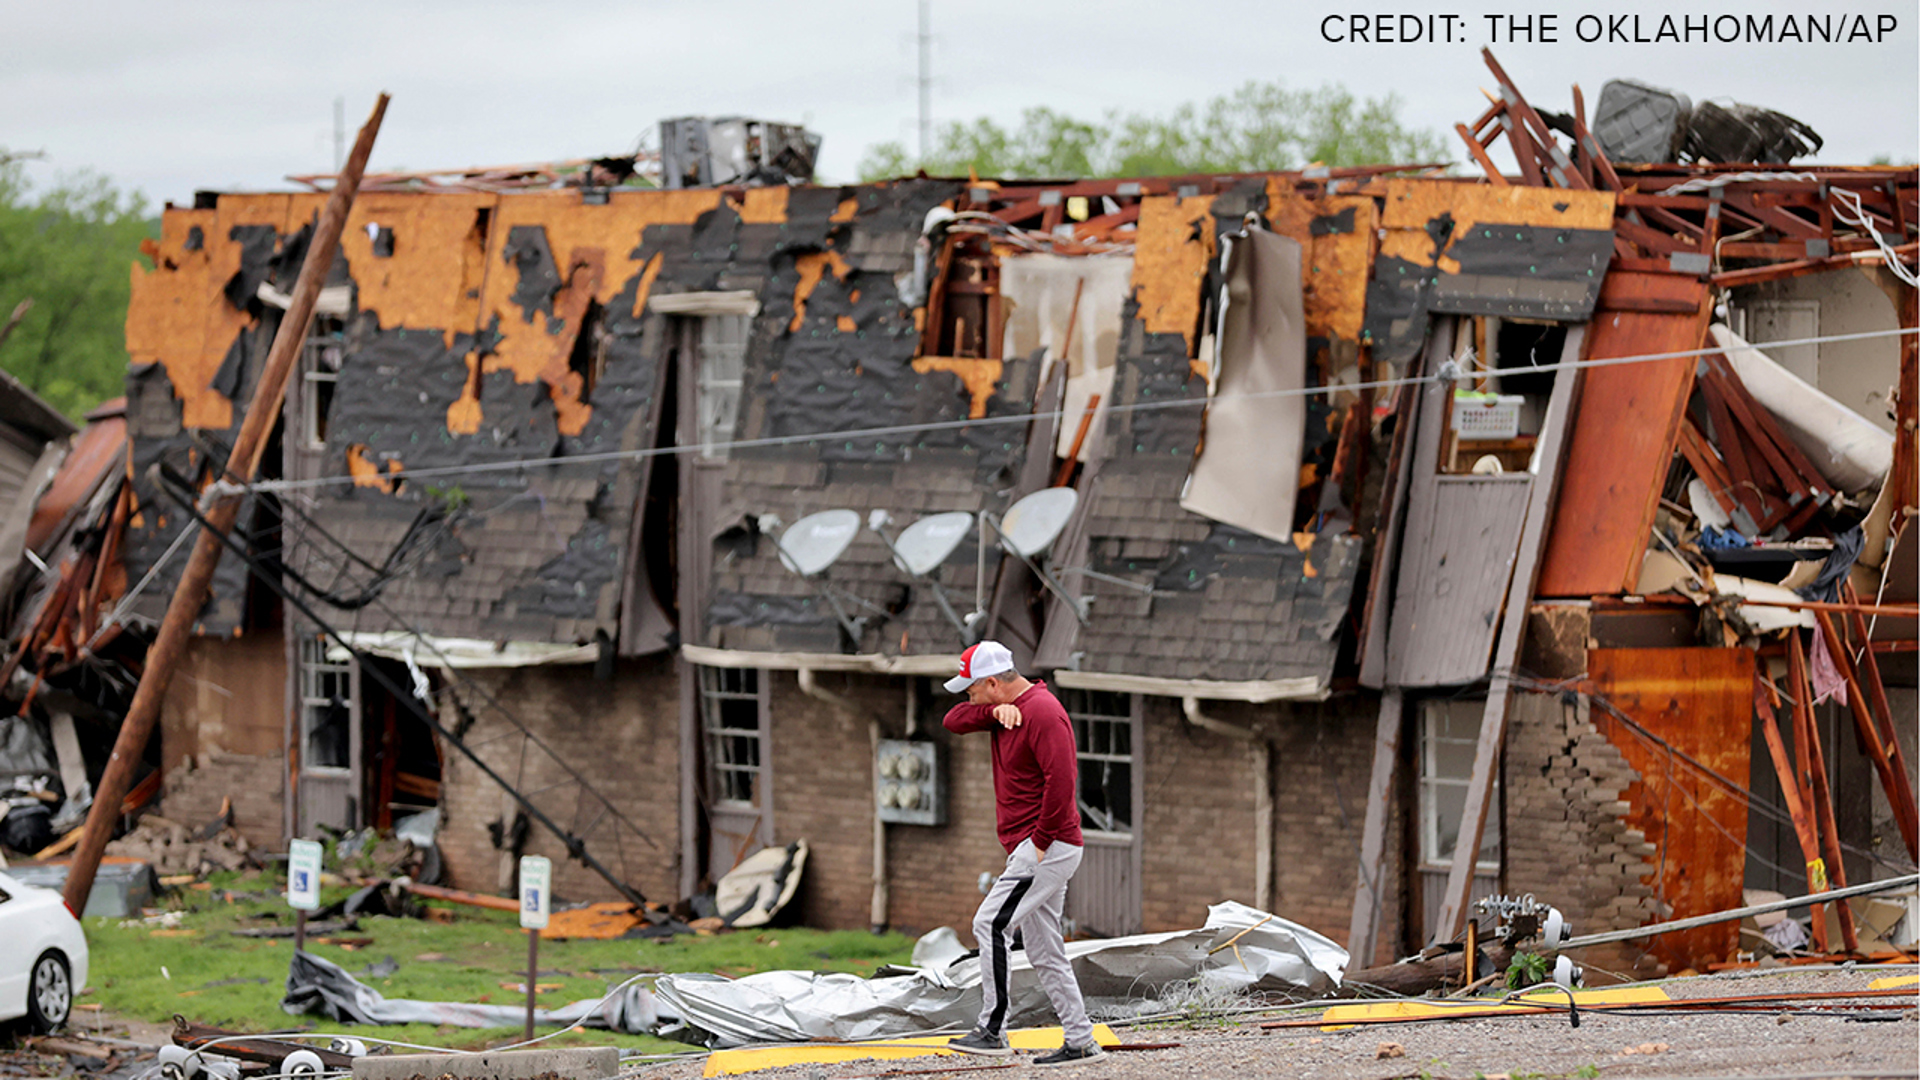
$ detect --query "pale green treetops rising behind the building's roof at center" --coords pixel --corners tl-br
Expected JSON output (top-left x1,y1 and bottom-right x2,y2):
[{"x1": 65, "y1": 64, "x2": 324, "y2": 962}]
[{"x1": 860, "y1": 83, "x2": 1446, "y2": 181}]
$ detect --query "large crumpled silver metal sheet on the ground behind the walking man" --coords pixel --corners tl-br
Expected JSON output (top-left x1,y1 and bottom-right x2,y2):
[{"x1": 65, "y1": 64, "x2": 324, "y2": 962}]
[{"x1": 653, "y1": 901, "x2": 1348, "y2": 1049}]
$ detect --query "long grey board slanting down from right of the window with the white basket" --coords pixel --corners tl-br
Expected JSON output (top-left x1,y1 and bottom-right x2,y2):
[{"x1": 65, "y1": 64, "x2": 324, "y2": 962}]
[{"x1": 1434, "y1": 327, "x2": 1592, "y2": 938}]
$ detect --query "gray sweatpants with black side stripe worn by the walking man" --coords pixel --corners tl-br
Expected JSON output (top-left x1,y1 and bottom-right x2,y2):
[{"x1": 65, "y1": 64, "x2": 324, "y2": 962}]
[{"x1": 973, "y1": 840, "x2": 1092, "y2": 1045}]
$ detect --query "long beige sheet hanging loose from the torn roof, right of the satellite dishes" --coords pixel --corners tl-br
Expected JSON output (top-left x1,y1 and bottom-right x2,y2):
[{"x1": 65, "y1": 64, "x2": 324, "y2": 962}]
[{"x1": 1181, "y1": 229, "x2": 1308, "y2": 540}]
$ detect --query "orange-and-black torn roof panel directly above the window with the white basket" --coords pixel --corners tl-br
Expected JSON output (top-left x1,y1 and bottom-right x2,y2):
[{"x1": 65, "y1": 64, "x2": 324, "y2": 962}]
[{"x1": 1365, "y1": 181, "x2": 1613, "y2": 363}]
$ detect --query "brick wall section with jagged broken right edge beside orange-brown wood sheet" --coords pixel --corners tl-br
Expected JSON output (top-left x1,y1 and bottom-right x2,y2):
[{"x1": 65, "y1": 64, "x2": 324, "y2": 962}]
[{"x1": 1505, "y1": 694, "x2": 1665, "y2": 982}]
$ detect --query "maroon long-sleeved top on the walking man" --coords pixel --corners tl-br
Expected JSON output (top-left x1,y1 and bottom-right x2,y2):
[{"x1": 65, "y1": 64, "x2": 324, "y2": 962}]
[{"x1": 941, "y1": 682, "x2": 1085, "y2": 851}]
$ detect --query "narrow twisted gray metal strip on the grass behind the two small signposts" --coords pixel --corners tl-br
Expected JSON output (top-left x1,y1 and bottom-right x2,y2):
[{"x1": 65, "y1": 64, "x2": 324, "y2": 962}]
[{"x1": 280, "y1": 953, "x2": 660, "y2": 1036}]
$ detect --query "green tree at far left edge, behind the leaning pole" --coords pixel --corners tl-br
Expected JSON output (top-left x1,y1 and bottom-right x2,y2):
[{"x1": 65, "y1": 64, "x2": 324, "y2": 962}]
[{"x1": 0, "y1": 152, "x2": 159, "y2": 421}]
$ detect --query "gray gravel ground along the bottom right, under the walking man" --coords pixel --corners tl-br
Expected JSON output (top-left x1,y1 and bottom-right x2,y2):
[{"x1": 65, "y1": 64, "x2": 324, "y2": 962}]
[{"x1": 639, "y1": 967, "x2": 1920, "y2": 1080}]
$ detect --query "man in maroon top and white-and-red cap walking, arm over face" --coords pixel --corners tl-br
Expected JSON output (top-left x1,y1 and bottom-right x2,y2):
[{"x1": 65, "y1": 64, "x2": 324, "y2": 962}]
[{"x1": 943, "y1": 642, "x2": 1106, "y2": 1065}]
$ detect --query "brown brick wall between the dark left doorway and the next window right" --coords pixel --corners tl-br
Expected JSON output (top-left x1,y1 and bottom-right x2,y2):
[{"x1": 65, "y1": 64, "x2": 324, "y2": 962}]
[{"x1": 440, "y1": 657, "x2": 680, "y2": 901}]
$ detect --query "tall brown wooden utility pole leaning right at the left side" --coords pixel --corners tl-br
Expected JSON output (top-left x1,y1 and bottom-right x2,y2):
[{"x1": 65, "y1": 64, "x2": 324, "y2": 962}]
[{"x1": 65, "y1": 94, "x2": 388, "y2": 915}]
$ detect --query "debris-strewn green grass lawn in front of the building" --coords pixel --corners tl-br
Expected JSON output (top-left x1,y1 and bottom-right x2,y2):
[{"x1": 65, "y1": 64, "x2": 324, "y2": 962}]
[{"x1": 81, "y1": 872, "x2": 914, "y2": 1051}]
